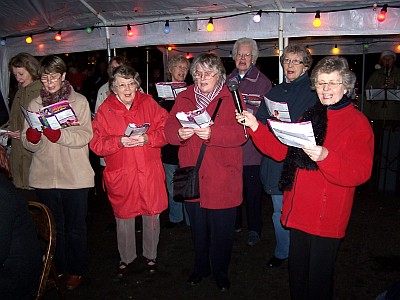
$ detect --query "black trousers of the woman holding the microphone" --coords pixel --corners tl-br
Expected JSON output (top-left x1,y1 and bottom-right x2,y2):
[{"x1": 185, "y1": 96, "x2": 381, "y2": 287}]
[{"x1": 289, "y1": 229, "x2": 341, "y2": 300}]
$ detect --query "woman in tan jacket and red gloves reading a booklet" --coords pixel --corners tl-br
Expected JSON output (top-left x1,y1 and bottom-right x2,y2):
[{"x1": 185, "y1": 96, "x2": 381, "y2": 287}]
[{"x1": 21, "y1": 55, "x2": 94, "y2": 289}]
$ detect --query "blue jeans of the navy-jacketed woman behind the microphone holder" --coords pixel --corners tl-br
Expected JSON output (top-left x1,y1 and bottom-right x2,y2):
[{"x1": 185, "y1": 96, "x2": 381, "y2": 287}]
[{"x1": 271, "y1": 195, "x2": 290, "y2": 259}]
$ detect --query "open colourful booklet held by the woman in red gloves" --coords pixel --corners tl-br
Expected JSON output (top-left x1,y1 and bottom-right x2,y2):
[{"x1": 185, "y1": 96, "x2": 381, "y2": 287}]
[{"x1": 21, "y1": 100, "x2": 79, "y2": 131}]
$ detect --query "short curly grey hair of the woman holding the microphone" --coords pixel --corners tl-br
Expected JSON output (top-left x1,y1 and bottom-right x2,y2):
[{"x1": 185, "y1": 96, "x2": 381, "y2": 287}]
[{"x1": 310, "y1": 56, "x2": 356, "y2": 96}]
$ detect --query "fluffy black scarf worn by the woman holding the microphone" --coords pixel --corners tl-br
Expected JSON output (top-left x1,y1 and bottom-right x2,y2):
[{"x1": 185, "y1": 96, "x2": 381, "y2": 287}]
[{"x1": 279, "y1": 96, "x2": 351, "y2": 191}]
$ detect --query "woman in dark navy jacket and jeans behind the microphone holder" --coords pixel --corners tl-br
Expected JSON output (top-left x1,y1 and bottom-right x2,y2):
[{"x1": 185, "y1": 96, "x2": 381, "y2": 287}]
[{"x1": 256, "y1": 44, "x2": 318, "y2": 268}]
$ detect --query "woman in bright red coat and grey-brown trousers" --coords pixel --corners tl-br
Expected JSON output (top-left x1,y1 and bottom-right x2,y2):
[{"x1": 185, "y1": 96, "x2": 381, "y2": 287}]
[{"x1": 90, "y1": 66, "x2": 168, "y2": 277}]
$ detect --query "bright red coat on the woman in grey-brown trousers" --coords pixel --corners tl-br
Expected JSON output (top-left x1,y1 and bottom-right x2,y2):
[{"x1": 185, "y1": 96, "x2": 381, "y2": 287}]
[{"x1": 90, "y1": 91, "x2": 168, "y2": 219}]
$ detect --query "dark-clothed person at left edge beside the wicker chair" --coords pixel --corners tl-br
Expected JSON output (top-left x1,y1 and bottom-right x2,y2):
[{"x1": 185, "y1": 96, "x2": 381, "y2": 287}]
[{"x1": 0, "y1": 146, "x2": 43, "y2": 300}]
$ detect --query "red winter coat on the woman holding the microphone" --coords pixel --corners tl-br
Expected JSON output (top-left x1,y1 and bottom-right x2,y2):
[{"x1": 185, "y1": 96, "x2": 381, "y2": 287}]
[{"x1": 249, "y1": 105, "x2": 374, "y2": 238}]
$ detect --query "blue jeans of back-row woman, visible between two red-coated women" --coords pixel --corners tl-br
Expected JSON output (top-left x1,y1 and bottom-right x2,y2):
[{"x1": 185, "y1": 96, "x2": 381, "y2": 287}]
[{"x1": 163, "y1": 163, "x2": 190, "y2": 226}]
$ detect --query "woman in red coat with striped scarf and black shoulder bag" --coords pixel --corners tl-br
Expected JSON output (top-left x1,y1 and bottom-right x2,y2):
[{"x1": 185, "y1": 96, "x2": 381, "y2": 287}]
[{"x1": 165, "y1": 54, "x2": 246, "y2": 291}]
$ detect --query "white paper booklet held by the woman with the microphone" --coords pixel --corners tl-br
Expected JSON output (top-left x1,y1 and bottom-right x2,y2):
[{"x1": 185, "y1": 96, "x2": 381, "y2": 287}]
[{"x1": 268, "y1": 119, "x2": 316, "y2": 148}]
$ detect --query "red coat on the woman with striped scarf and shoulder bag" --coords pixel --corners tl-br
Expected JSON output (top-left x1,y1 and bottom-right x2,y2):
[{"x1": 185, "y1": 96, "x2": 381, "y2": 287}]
[{"x1": 165, "y1": 85, "x2": 246, "y2": 209}]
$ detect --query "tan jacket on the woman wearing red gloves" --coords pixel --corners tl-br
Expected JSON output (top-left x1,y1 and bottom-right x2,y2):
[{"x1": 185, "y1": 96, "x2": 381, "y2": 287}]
[{"x1": 21, "y1": 91, "x2": 94, "y2": 189}]
